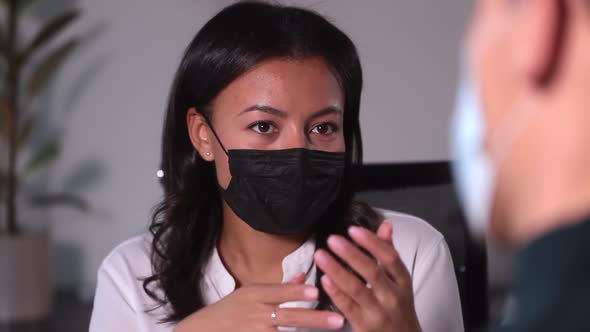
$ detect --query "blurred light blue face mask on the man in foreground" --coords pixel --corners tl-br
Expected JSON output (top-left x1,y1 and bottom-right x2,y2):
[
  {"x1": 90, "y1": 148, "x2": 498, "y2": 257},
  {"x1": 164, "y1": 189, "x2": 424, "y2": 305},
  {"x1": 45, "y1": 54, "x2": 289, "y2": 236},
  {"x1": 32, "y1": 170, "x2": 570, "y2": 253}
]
[{"x1": 450, "y1": 69, "x2": 497, "y2": 238}]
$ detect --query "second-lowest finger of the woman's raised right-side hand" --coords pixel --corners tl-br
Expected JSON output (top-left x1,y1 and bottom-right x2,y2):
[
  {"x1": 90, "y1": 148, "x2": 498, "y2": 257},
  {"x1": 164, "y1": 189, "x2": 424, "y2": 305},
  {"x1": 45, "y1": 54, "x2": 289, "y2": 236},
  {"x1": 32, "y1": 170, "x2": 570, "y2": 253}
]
[{"x1": 328, "y1": 235, "x2": 390, "y2": 292}]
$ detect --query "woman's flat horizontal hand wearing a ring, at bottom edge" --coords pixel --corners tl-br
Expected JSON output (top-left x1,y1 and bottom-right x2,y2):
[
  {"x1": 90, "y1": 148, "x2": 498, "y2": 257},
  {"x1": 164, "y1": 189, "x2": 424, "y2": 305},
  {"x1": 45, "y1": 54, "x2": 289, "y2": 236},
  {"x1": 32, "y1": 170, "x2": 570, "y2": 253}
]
[{"x1": 174, "y1": 275, "x2": 344, "y2": 332}]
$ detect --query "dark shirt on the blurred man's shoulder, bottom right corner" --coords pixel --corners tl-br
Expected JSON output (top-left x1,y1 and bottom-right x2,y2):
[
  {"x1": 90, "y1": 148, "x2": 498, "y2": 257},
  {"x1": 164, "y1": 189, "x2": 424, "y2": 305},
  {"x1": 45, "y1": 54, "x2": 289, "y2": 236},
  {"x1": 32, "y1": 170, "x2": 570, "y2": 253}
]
[{"x1": 497, "y1": 218, "x2": 590, "y2": 332}]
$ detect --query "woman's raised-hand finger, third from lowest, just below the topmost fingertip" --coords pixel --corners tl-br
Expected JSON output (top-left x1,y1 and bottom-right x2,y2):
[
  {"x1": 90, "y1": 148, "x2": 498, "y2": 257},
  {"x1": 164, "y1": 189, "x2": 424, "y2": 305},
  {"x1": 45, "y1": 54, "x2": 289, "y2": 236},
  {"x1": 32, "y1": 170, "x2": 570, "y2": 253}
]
[{"x1": 348, "y1": 225, "x2": 410, "y2": 287}]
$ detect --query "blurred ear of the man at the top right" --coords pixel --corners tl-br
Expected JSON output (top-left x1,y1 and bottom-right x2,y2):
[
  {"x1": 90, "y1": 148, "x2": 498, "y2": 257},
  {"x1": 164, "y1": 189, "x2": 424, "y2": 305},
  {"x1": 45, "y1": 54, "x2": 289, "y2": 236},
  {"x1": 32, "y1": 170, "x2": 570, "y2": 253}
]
[{"x1": 510, "y1": 0, "x2": 566, "y2": 85}]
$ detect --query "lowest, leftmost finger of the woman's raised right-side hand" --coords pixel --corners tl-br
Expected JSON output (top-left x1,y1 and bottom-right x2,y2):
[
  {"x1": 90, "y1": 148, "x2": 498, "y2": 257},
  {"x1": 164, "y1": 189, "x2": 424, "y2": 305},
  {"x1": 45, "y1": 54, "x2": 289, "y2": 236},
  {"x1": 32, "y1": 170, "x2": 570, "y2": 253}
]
[{"x1": 314, "y1": 249, "x2": 377, "y2": 311}]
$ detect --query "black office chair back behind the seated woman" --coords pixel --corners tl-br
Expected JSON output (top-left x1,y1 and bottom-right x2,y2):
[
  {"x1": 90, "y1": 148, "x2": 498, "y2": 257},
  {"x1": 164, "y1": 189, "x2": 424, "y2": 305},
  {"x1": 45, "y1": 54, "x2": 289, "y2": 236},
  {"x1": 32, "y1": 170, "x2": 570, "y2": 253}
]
[{"x1": 357, "y1": 162, "x2": 489, "y2": 331}]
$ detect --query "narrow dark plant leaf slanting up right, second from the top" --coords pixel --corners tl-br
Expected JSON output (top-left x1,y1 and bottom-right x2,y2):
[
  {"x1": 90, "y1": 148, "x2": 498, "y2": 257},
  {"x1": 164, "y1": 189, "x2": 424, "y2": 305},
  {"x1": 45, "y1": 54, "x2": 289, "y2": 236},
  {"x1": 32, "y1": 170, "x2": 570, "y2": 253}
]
[{"x1": 26, "y1": 38, "x2": 78, "y2": 97}]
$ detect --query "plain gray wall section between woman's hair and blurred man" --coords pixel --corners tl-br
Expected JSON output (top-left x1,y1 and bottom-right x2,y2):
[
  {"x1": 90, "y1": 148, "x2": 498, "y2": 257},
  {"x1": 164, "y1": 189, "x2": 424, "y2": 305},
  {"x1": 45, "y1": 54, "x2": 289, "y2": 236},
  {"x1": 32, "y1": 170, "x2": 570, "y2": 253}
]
[{"x1": 308, "y1": 0, "x2": 472, "y2": 162}]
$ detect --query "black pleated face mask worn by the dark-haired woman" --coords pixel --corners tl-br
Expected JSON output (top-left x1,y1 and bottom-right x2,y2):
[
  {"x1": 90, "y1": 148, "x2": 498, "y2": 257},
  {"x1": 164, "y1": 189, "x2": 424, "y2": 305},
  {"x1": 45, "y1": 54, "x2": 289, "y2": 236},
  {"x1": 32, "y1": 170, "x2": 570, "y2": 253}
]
[{"x1": 210, "y1": 118, "x2": 345, "y2": 235}]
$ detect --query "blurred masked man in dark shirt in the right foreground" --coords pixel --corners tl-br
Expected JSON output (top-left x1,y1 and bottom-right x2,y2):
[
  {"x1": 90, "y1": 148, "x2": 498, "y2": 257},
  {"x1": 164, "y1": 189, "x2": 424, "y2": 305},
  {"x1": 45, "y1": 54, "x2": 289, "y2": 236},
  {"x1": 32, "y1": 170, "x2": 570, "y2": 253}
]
[{"x1": 453, "y1": 0, "x2": 590, "y2": 332}]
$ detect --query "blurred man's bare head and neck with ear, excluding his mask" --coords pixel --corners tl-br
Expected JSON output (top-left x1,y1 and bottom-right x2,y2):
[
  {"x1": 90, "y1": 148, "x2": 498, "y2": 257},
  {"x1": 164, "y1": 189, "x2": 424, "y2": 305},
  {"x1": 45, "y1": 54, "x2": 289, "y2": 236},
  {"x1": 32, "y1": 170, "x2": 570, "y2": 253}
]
[{"x1": 466, "y1": 0, "x2": 590, "y2": 244}]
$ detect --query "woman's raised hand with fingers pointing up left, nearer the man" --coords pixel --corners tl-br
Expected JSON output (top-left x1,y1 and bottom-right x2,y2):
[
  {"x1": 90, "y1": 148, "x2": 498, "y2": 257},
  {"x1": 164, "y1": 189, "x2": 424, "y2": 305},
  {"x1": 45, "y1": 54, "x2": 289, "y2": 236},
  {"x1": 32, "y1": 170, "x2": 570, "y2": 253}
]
[{"x1": 314, "y1": 222, "x2": 421, "y2": 332}]
